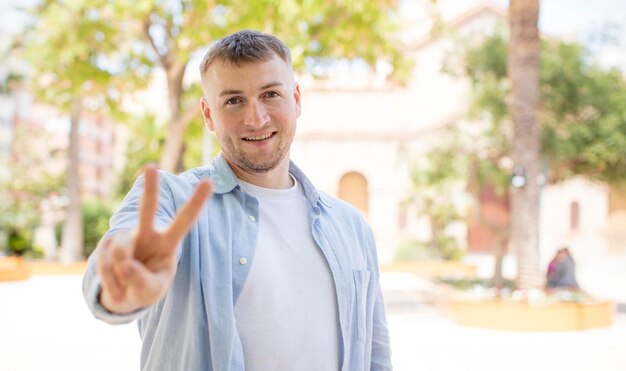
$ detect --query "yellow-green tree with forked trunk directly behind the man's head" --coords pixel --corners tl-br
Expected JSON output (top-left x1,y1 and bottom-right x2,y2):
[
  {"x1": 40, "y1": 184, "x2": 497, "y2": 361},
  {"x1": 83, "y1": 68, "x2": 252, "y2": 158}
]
[{"x1": 101, "y1": 0, "x2": 409, "y2": 171}]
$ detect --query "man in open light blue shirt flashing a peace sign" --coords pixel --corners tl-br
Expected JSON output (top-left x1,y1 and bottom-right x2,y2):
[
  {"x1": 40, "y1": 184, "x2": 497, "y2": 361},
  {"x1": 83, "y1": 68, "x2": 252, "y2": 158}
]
[{"x1": 83, "y1": 31, "x2": 391, "y2": 371}]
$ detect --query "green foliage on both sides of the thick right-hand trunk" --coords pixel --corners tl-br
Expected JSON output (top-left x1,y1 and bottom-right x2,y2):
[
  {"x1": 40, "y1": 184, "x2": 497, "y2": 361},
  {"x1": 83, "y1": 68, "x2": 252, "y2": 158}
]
[{"x1": 458, "y1": 34, "x2": 626, "y2": 183}]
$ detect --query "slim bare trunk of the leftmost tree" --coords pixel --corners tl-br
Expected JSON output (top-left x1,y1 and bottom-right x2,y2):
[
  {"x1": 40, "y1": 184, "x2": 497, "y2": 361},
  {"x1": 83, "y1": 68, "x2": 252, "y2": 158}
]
[{"x1": 60, "y1": 98, "x2": 83, "y2": 262}]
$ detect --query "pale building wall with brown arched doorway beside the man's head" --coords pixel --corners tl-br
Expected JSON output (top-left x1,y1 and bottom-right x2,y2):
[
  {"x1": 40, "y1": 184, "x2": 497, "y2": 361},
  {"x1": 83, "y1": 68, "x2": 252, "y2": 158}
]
[{"x1": 292, "y1": 4, "x2": 497, "y2": 261}]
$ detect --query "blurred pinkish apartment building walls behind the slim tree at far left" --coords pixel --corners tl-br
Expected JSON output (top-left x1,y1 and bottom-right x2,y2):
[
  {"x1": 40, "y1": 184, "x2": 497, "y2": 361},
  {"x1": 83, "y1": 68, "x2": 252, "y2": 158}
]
[{"x1": 6, "y1": 90, "x2": 115, "y2": 257}]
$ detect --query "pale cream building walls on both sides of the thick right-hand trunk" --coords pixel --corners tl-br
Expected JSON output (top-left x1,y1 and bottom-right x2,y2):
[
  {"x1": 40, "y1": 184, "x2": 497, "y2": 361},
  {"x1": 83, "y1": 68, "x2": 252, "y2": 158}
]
[{"x1": 292, "y1": 4, "x2": 608, "y2": 264}]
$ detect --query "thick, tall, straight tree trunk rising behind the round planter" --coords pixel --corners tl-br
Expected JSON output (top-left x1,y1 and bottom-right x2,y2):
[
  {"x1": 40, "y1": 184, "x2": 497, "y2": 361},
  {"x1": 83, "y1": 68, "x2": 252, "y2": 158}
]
[{"x1": 508, "y1": 0, "x2": 543, "y2": 290}]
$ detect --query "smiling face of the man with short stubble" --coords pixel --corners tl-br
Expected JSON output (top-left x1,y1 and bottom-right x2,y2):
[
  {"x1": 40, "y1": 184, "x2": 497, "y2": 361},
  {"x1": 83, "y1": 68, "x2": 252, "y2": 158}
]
[{"x1": 202, "y1": 55, "x2": 300, "y2": 174}]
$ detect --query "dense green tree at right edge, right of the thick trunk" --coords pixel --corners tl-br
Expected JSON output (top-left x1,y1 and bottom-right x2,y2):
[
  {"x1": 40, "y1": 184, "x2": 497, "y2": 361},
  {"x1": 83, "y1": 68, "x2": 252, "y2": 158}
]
[{"x1": 540, "y1": 42, "x2": 626, "y2": 184}]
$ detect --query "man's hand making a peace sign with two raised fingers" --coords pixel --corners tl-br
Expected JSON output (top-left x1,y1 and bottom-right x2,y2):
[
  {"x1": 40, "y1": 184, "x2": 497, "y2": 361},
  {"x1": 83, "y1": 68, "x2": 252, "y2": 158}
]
[{"x1": 97, "y1": 165, "x2": 213, "y2": 313}]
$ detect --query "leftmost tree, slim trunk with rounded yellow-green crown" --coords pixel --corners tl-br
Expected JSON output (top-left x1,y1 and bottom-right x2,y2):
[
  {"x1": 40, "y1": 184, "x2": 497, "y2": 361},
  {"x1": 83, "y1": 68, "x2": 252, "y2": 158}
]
[{"x1": 17, "y1": 0, "x2": 138, "y2": 260}]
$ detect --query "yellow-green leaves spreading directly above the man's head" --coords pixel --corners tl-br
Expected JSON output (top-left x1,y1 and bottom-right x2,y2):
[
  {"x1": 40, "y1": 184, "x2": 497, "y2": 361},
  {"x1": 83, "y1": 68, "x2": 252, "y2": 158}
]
[{"x1": 121, "y1": 0, "x2": 399, "y2": 78}]
